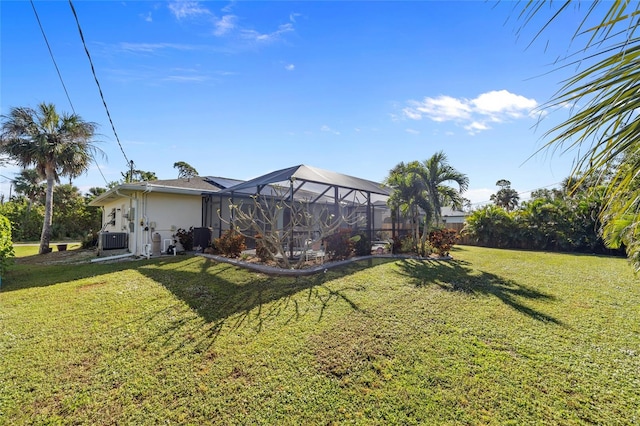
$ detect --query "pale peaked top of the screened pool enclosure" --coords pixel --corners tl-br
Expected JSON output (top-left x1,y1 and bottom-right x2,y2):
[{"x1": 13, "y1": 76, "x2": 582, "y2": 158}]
[{"x1": 219, "y1": 165, "x2": 392, "y2": 202}]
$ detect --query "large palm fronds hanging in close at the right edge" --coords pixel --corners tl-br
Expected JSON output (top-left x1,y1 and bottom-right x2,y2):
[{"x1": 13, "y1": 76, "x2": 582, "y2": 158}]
[{"x1": 516, "y1": 0, "x2": 640, "y2": 270}]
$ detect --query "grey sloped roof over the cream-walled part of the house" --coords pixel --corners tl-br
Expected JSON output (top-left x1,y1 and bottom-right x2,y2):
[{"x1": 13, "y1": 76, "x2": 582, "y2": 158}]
[{"x1": 89, "y1": 176, "x2": 221, "y2": 206}]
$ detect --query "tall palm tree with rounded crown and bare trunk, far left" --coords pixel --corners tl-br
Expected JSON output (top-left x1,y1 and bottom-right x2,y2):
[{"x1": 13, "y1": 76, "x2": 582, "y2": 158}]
[{"x1": 0, "y1": 103, "x2": 98, "y2": 254}]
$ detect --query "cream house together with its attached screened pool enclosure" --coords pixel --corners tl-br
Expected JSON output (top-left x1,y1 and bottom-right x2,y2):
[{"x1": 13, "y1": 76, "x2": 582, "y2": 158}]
[{"x1": 90, "y1": 165, "x2": 391, "y2": 256}]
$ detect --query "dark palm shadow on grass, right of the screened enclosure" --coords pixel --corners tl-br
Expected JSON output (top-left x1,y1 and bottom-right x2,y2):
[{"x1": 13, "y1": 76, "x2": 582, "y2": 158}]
[{"x1": 399, "y1": 259, "x2": 563, "y2": 325}]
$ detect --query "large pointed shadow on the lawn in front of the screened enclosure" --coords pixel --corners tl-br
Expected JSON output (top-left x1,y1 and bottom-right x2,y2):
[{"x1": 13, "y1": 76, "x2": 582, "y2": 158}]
[{"x1": 138, "y1": 258, "x2": 393, "y2": 346}]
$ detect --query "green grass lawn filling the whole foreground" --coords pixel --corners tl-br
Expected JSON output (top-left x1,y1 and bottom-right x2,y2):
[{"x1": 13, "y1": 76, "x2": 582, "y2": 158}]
[{"x1": 0, "y1": 247, "x2": 640, "y2": 425}]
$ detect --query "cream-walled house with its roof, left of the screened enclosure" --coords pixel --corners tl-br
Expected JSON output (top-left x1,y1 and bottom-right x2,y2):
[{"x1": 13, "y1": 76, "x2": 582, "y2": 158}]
[{"x1": 90, "y1": 177, "x2": 241, "y2": 256}]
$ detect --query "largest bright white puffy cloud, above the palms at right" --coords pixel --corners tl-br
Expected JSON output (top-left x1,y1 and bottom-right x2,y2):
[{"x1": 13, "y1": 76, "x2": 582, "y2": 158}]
[{"x1": 402, "y1": 90, "x2": 539, "y2": 134}]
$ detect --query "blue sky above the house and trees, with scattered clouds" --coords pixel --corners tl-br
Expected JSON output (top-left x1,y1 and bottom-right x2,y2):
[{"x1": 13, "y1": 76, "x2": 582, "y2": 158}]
[{"x1": 0, "y1": 0, "x2": 578, "y2": 205}]
